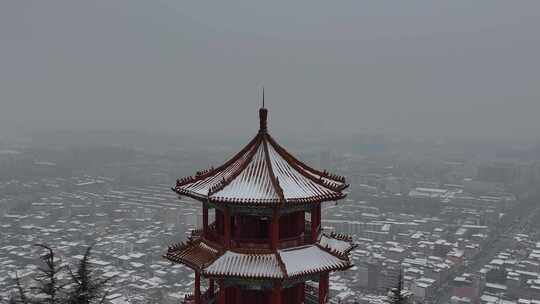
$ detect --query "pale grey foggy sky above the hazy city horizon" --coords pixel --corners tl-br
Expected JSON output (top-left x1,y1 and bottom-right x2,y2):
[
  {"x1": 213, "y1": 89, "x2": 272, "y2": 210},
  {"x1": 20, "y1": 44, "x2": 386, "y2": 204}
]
[{"x1": 0, "y1": 0, "x2": 540, "y2": 139}]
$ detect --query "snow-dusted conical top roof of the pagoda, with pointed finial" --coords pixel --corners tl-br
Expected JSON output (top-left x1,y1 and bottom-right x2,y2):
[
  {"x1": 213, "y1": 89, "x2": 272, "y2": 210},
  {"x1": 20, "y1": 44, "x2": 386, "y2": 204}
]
[{"x1": 173, "y1": 107, "x2": 348, "y2": 206}]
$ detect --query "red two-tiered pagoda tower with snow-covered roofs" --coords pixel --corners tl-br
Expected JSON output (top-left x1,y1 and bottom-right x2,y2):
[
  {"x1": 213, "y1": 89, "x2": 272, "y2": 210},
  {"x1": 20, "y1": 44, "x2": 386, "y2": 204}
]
[{"x1": 164, "y1": 102, "x2": 354, "y2": 304}]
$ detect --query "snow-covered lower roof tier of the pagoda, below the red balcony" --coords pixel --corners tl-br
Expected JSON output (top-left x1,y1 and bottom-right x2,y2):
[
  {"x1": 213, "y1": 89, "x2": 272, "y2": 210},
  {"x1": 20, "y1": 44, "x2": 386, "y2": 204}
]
[{"x1": 165, "y1": 234, "x2": 354, "y2": 279}]
